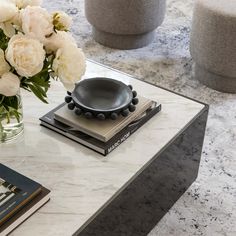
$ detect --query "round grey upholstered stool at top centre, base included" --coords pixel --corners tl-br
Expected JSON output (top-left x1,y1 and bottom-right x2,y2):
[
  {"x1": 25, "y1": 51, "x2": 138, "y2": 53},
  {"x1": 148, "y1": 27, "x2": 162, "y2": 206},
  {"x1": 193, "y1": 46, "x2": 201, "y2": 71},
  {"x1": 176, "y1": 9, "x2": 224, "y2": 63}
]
[{"x1": 85, "y1": 0, "x2": 166, "y2": 49}]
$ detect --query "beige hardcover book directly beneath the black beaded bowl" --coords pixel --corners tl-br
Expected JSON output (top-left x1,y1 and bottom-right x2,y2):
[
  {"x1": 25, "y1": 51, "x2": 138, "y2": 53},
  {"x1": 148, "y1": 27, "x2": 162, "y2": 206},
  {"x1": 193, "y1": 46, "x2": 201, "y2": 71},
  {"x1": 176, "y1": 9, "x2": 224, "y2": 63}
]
[{"x1": 54, "y1": 97, "x2": 152, "y2": 142}]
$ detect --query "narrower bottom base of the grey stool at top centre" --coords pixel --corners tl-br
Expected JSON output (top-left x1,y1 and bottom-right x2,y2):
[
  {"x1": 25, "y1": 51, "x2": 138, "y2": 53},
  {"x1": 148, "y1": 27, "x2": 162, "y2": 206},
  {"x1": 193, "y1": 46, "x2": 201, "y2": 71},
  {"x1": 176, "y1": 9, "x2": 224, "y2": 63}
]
[{"x1": 93, "y1": 27, "x2": 155, "y2": 49}]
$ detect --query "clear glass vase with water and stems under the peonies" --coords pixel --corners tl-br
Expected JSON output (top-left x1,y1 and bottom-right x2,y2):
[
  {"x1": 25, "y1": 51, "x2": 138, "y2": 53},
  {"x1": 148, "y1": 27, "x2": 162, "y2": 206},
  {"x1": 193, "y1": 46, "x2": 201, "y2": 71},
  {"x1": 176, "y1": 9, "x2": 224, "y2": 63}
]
[{"x1": 0, "y1": 92, "x2": 24, "y2": 143}]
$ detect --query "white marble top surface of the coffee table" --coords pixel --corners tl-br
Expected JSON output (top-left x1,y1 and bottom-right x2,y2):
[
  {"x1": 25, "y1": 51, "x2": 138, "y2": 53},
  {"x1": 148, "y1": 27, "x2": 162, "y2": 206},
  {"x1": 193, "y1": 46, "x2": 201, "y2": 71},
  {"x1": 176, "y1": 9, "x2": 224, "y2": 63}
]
[{"x1": 0, "y1": 61, "x2": 204, "y2": 236}]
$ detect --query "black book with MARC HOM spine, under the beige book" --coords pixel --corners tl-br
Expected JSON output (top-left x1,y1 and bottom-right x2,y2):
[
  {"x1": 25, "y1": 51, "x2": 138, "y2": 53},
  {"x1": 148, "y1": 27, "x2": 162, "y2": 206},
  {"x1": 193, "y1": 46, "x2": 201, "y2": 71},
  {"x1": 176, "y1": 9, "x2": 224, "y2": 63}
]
[{"x1": 40, "y1": 102, "x2": 161, "y2": 156}]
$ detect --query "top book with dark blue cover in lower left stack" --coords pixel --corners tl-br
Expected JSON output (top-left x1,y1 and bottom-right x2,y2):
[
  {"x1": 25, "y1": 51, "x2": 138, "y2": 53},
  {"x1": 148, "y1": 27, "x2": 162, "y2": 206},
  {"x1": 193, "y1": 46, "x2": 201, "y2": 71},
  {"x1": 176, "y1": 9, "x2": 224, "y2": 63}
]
[{"x1": 0, "y1": 164, "x2": 41, "y2": 226}]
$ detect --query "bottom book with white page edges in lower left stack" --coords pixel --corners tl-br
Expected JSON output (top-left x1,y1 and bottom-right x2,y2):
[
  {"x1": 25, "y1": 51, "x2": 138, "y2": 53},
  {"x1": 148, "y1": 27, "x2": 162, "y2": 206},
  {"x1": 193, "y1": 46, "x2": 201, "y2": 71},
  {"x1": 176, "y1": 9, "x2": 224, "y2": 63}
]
[{"x1": 0, "y1": 187, "x2": 50, "y2": 235}]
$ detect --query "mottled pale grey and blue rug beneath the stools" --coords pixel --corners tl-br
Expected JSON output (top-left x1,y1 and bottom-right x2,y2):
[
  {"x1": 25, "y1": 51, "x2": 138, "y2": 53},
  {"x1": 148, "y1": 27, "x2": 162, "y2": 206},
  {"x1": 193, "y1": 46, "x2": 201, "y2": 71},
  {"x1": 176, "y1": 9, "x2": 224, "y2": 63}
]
[{"x1": 44, "y1": 0, "x2": 236, "y2": 236}]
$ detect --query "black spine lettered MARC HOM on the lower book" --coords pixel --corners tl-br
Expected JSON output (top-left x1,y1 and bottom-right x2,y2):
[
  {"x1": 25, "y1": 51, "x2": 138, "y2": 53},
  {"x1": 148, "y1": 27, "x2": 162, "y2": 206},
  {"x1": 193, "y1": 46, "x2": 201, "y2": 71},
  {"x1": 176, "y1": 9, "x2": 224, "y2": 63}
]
[{"x1": 104, "y1": 105, "x2": 161, "y2": 156}]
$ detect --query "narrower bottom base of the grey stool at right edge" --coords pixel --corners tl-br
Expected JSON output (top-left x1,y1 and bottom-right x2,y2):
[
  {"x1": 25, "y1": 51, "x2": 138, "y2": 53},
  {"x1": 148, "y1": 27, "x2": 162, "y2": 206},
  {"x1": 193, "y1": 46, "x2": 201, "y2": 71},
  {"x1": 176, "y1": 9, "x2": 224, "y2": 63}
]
[{"x1": 195, "y1": 64, "x2": 236, "y2": 93}]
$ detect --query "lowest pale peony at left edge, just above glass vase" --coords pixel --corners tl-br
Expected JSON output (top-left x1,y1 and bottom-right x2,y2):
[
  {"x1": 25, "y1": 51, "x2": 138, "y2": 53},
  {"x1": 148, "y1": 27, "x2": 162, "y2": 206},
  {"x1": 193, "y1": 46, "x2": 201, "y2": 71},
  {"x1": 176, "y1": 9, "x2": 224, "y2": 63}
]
[{"x1": 0, "y1": 72, "x2": 20, "y2": 97}]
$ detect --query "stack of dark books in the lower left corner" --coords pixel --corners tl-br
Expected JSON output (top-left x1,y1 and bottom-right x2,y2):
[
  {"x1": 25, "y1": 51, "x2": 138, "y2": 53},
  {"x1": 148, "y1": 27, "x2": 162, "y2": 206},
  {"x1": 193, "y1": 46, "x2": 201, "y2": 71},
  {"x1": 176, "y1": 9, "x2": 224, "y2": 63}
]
[{"x1": 0, "y1": 164, "x2": 50, "y2": 236}]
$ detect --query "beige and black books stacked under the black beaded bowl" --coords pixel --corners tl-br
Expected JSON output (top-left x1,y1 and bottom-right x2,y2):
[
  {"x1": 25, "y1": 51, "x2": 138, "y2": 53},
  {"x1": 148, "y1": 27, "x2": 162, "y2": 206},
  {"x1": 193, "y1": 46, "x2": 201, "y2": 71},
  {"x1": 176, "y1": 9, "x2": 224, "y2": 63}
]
[{"x1": 40, "y1": 97, "x2": 161, "y2": 156}]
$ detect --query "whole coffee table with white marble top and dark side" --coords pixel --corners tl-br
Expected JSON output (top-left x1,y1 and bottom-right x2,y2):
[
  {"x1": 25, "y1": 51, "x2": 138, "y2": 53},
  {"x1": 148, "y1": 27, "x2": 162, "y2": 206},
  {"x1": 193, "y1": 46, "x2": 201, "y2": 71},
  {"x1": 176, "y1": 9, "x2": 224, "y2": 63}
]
[{"x1": 0, "y1": 61, "x2": 208, "y2": 236}]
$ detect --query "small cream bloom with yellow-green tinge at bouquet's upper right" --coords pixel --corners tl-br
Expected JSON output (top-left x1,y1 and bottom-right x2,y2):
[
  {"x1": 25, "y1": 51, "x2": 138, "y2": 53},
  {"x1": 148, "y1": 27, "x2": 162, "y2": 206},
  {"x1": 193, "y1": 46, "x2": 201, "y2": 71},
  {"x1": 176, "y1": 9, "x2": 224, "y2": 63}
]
[{"x1": 52, "y1": 11, "x2": 72, "y2": 31}]
